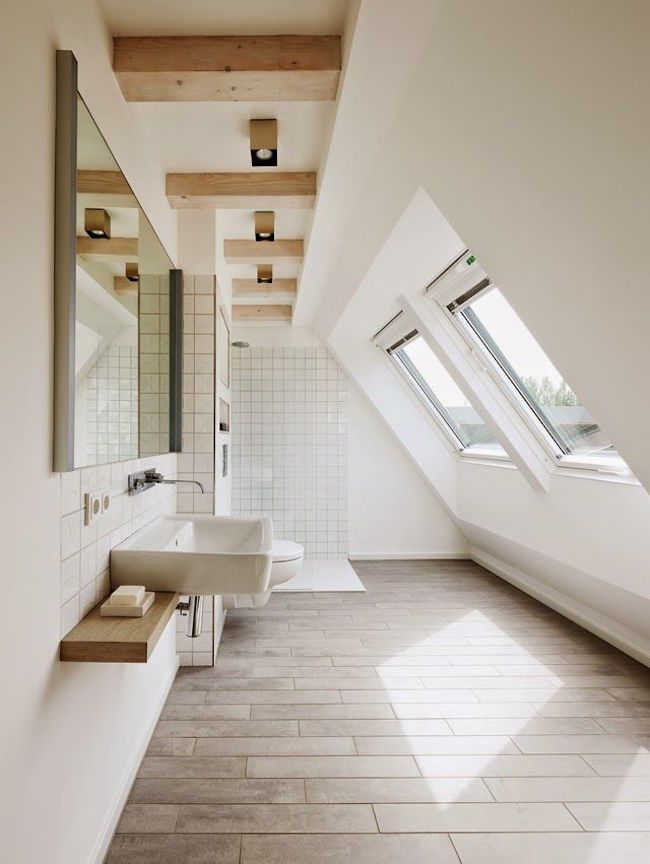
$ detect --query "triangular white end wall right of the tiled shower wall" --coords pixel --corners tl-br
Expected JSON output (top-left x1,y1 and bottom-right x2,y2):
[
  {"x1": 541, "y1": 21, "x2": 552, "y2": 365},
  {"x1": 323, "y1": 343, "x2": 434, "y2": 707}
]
[{"x1": 348, "y1": 384, "x2": 468, "y2": 558}]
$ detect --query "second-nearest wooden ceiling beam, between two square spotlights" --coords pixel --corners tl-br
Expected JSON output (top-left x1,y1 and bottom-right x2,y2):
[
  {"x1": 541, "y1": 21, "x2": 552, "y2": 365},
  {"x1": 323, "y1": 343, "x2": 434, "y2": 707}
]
[{"x1": 167, "y1": 171, "x2": 316, "y2": 210}]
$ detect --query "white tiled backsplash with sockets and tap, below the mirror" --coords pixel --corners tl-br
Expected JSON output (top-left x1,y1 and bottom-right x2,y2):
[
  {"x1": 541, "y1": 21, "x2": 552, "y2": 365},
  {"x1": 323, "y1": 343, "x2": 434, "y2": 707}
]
[{"x1": 60, "y1": 453, "x2": 176, "y2": 636}]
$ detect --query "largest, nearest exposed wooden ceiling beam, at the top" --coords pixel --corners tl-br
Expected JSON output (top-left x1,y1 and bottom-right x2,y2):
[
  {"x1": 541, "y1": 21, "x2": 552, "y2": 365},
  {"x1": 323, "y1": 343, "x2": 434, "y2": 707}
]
[{"x1": 113, "y1": 36, "x2": 341, "y2": 102}]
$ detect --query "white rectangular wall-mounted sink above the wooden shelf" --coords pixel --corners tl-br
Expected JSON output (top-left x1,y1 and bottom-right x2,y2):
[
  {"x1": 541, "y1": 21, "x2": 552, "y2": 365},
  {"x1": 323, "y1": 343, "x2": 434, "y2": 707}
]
[{"x1": 111, "y1": 515, "x2": 273, "y2": 595}]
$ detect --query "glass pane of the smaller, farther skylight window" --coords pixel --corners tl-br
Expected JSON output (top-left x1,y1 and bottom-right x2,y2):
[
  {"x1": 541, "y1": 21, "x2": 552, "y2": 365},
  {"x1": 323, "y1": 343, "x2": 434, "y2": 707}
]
[{"x1": 395, "y1": 336, "x2": 502, "y2": 451}]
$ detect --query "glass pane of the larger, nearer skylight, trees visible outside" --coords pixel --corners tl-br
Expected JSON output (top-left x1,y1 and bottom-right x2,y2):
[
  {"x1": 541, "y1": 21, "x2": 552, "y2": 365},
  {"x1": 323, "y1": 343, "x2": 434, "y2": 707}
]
[{"x1": 462, "y1": 288, "x2": 614, "y2": 454}]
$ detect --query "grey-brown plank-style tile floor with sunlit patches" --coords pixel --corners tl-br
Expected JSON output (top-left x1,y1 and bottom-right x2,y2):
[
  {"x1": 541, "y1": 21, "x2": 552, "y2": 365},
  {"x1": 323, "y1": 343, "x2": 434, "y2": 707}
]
[{"x1": 107, "y1": 561, "x2": 650, "y2": 864}]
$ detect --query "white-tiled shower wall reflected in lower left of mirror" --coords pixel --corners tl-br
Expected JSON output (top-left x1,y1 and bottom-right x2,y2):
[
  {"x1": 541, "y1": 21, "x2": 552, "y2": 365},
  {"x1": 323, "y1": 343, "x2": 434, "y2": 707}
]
[{"x1": 81, "y1": 344, "x2": 138, "y2": 465}]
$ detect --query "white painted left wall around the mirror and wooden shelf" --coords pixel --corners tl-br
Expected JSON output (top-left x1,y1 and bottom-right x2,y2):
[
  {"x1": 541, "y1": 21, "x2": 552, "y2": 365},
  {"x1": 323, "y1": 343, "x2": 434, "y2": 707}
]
[{"x1": 0, "y1": 0, "x2": 176, "y2": 864}]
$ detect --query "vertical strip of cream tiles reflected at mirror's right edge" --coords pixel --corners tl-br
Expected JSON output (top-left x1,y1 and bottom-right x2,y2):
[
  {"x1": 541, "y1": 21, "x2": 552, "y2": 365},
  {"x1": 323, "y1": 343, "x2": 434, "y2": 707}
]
[{"x1": 138, "y1": 274, "x2": 169, "y2": 456}]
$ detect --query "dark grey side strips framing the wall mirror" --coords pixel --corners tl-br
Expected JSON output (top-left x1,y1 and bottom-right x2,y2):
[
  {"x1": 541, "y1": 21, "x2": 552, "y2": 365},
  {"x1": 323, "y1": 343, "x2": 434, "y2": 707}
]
[{"x1": 53, "y1": 51, "x2": 183, "y2": 472}]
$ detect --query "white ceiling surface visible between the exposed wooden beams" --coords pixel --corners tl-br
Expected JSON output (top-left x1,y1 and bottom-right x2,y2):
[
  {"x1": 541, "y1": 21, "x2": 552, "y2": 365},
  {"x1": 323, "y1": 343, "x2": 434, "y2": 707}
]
[{"x1": 99, "y1": 0, "x2": 356, "y2": 310}]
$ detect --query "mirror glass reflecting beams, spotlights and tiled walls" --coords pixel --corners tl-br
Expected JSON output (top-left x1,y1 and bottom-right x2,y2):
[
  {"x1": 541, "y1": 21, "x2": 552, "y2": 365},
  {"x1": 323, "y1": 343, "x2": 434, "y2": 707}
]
[{"x1": 74, "y1": 97, "x2": 172, "y2": 467}]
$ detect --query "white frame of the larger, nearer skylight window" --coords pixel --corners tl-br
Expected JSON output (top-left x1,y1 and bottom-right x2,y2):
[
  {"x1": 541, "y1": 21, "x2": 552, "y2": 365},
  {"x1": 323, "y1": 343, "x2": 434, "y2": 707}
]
[{"x1": 424, "y1": 249, "x2": 631, "y2": 479}]
